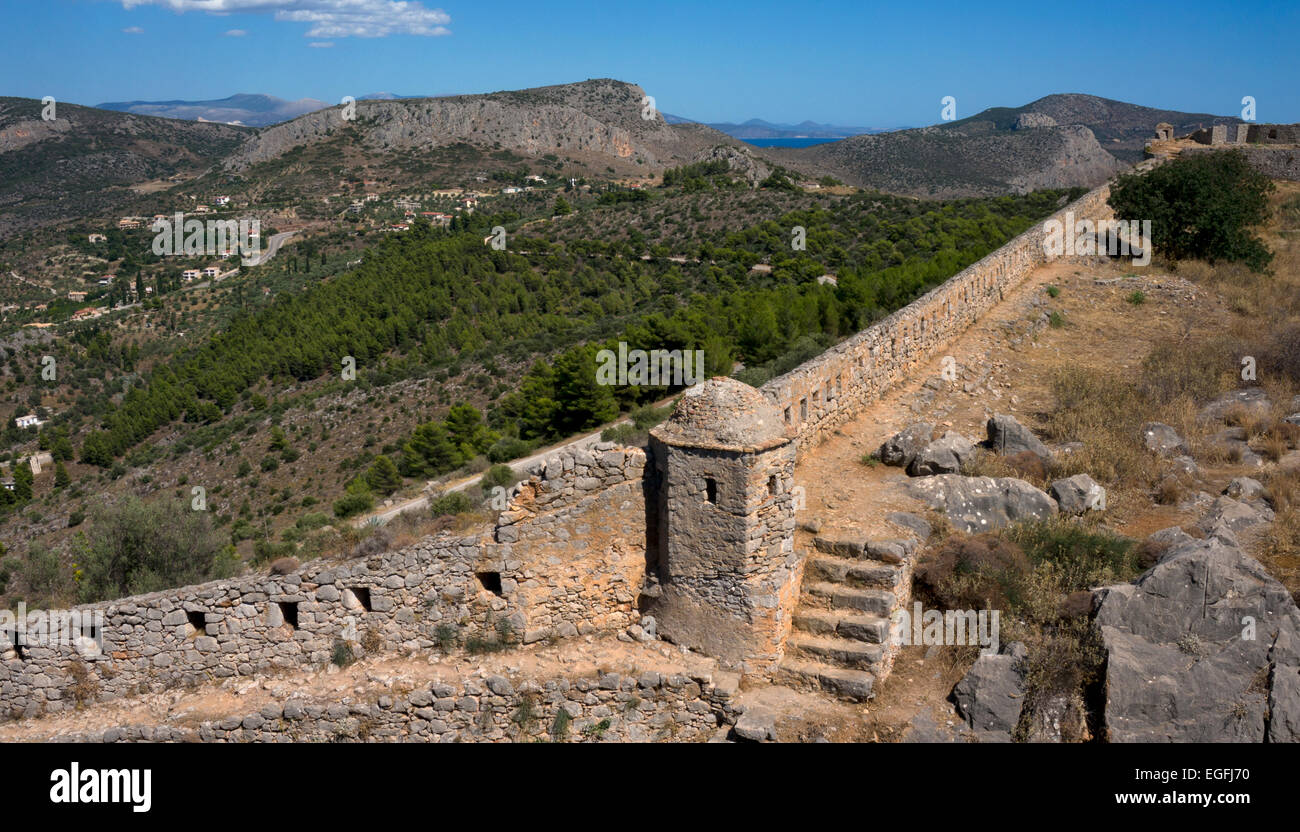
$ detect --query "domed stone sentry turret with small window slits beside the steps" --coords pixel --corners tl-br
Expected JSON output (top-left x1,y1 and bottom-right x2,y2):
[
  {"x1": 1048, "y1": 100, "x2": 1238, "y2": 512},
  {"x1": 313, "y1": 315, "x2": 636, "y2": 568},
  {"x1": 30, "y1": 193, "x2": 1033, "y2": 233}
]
[{"x1": 650, "y1": 377, "x2": 801, "y2": 672}]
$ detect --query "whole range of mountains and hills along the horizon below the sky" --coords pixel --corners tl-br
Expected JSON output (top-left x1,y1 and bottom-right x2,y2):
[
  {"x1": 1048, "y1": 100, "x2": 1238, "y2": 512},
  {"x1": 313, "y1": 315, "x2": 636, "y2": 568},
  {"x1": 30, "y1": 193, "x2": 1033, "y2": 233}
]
[{"x1": 0, "y1": 78, "x2": 1258, "y2": 237}]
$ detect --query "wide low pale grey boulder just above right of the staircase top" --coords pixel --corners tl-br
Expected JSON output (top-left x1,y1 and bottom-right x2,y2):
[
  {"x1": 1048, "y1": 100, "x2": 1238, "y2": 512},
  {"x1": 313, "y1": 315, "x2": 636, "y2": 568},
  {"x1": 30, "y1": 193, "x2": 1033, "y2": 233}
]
[{"x1": 907, "y1": 473, "x2": 1057, "y2": 533}]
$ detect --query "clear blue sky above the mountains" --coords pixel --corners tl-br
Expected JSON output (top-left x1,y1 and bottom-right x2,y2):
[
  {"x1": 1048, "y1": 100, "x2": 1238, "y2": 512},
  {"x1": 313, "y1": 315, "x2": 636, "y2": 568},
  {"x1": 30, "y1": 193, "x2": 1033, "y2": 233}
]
[{"x1": 0, "y1": 0, "x2": 1300, "y2": 126}]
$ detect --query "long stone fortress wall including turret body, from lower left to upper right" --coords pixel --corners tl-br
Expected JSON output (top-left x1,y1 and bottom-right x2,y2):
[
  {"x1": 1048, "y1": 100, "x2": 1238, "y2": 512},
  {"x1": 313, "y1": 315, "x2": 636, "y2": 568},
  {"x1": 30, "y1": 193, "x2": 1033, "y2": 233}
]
[{"x1": 0, "y1": 176, "x2": 1123, "y2": 722}]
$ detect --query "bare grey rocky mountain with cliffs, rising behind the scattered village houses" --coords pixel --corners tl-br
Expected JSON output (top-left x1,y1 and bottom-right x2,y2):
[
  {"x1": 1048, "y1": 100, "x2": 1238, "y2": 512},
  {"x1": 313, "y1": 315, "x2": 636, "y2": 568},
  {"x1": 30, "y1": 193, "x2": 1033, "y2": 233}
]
[{"x1": 226, "y1": 78, "x2": 735, "y2": 176}]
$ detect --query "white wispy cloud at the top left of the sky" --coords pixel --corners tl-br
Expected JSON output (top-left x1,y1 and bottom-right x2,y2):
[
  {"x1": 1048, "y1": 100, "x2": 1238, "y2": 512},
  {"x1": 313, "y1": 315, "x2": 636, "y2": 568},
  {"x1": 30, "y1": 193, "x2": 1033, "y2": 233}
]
[{"x1": 122, "y1": 0, "x2": 451, "y2": 38}]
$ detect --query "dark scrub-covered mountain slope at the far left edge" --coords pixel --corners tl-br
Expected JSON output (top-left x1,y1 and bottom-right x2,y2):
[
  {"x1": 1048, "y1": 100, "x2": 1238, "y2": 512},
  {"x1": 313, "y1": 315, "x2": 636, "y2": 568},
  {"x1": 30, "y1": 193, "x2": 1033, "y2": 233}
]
[{"x1": 0, "y1": 98, "x2": 252, "y2": 237}]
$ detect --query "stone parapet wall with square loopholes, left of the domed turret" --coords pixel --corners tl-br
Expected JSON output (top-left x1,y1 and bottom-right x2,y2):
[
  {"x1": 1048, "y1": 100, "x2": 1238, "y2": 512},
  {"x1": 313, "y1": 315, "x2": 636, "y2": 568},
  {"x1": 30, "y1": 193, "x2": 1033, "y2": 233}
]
[{"x1": 0, "y1": 443, "x2": 645, "y2": 718}]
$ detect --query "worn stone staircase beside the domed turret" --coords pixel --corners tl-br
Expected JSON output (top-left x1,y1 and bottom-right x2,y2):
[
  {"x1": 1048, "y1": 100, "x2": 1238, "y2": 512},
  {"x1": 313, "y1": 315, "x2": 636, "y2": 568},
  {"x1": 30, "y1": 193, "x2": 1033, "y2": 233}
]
[{"x1": 776, "y1": 534, "x2": 917, "y2": 702}]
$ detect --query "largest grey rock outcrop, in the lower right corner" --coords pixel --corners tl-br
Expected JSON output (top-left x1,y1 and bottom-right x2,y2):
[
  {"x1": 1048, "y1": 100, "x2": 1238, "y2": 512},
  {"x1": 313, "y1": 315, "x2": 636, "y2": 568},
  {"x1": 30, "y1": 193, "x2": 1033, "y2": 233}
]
[{"x1": 1096, "y1": 540, "x2": 1300, "y2": 742}]
